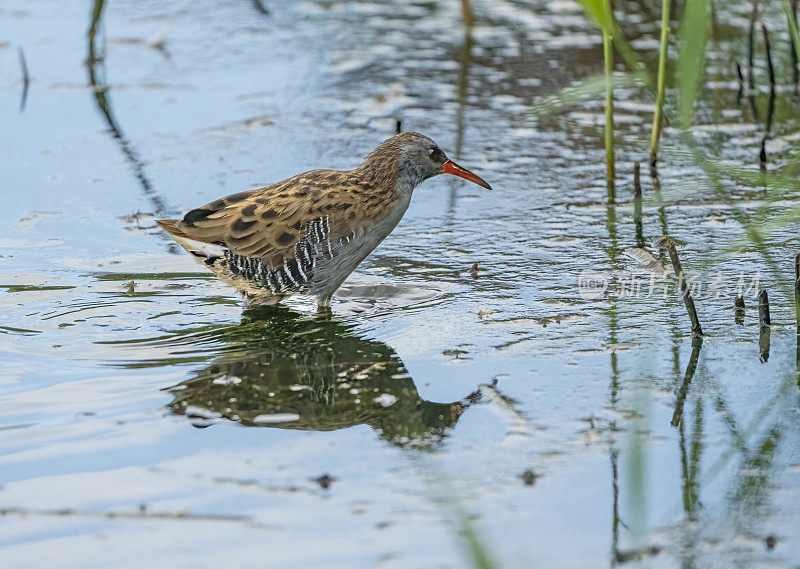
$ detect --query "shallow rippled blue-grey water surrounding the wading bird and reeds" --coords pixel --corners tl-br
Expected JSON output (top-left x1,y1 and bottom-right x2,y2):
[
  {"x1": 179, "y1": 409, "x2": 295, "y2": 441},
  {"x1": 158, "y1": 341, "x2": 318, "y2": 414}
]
[{"x1": 0, "y1": 0, "x2": 800, "y2": 568}]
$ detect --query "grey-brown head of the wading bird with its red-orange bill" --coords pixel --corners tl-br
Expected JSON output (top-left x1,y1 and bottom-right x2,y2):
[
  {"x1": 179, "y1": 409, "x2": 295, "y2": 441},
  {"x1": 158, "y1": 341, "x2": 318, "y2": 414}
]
[{"x1": 364, "y1": 132, "x2": 492, "y2": 190}]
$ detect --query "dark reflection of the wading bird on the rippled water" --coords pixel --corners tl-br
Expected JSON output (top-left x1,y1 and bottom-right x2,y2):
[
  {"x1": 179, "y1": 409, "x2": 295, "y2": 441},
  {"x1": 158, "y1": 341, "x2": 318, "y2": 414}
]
[{"x1": 169, "y1": 307, "x2": 494, "y2": 447}]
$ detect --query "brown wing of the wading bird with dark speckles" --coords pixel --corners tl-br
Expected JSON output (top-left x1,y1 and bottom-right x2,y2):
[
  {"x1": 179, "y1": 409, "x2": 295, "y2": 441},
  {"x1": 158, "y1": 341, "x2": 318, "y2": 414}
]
[{"x1": 170, "y1": 170, "x2": 370, "y2": 267}]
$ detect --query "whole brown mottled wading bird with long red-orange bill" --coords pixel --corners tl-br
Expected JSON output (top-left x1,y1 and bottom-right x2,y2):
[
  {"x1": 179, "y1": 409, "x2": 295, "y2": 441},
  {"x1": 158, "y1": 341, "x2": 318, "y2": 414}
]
[{"x1": 158, "y1": 132, "x2": 491, "y2": 306}]
